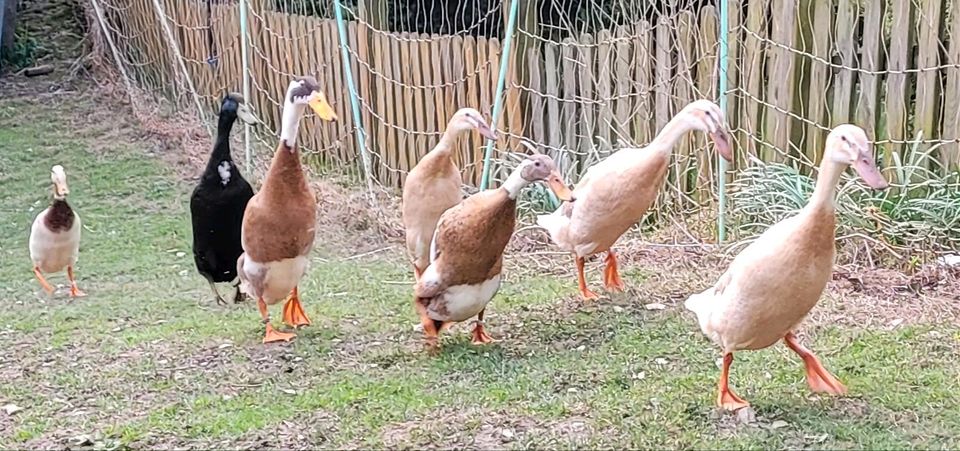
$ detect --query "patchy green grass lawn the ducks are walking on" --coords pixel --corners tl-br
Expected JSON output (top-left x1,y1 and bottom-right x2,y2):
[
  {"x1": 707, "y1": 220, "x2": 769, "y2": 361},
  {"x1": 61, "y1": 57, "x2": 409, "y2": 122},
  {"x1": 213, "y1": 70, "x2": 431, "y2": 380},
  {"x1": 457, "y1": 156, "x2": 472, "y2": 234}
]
[{"x1": 0, "y1": 94, "x2": 960, "y2": 449}]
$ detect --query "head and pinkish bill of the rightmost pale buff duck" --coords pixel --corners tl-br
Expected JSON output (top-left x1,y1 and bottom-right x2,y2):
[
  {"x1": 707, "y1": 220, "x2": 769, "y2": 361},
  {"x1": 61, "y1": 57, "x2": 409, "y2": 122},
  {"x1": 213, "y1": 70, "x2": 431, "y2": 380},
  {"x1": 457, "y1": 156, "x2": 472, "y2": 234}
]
[{"x1": 823, "y1": 124, "x2": 889, "y2": 189}]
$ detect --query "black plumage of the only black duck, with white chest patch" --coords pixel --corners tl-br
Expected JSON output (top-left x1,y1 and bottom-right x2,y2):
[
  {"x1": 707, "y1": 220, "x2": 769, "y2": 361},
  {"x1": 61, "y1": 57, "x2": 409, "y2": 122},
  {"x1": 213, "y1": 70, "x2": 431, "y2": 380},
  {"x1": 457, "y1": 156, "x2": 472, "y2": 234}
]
[{"x1": 190, "y1": 94, "x2": 253, "y2": 303}]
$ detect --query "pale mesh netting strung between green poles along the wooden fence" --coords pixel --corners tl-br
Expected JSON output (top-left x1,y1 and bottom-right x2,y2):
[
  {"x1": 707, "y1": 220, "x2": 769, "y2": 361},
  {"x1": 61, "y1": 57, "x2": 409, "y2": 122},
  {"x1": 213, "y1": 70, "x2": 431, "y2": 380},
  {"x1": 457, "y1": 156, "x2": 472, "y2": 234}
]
[{"x1": 94, "y1": 0, "x2": 960, "y2": 254}]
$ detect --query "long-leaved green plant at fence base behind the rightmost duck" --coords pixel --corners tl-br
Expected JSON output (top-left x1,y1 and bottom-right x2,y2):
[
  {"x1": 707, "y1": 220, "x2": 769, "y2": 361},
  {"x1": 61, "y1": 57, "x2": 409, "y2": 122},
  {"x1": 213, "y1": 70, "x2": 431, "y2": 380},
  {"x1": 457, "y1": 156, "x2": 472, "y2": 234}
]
[{"x1": 731, "y1": 139, "x2": 960, "y2": 252}]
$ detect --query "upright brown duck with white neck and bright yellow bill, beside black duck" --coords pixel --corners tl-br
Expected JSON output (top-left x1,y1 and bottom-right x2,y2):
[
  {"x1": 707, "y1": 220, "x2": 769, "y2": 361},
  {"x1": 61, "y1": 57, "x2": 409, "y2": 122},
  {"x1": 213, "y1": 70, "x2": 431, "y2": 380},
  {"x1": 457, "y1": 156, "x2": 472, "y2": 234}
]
[{"x1": 237, "y1": 77, "x2": 337, "y2": 343}]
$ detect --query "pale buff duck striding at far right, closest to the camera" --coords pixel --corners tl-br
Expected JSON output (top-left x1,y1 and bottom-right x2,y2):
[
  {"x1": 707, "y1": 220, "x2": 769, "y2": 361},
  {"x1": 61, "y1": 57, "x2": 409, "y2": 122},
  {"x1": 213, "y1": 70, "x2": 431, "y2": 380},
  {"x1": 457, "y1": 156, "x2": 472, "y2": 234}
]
[{"x1": 685, "y1": 124, "x2": 887, "y2": 410}]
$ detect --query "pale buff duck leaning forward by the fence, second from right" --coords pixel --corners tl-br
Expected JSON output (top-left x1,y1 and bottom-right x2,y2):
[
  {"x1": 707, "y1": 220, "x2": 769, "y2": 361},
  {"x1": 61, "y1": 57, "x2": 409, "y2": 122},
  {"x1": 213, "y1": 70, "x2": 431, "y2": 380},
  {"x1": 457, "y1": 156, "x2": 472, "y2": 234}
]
[{"x1": 537, "y1": 100, "x2": 732, "y2": 300}]
